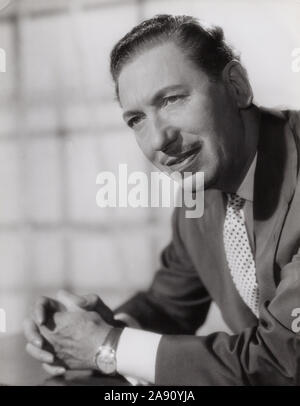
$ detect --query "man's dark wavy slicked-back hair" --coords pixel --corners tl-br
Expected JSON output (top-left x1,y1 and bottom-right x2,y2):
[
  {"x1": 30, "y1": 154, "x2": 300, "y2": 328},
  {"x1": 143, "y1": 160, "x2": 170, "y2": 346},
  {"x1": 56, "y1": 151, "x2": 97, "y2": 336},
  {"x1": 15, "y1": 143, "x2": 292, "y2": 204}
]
[{"x1": 110, "y1": 14, "x2": 239, "y2": 96}]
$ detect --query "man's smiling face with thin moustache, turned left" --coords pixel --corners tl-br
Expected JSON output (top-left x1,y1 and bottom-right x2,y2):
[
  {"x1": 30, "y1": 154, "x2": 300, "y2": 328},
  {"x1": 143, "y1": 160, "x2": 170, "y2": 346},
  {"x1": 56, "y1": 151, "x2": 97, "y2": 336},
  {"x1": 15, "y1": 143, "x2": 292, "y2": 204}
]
[{"x1": 118, "y1": 42, "x2": 242, "y2": 191}]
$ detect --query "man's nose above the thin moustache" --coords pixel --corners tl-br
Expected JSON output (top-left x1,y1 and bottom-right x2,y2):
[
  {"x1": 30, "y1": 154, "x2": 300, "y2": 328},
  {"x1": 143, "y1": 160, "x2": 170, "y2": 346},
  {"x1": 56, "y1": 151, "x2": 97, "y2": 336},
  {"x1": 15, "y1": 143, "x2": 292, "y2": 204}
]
[{"x1": 151, "y1": 117, "x2": 179, "y2": 152}]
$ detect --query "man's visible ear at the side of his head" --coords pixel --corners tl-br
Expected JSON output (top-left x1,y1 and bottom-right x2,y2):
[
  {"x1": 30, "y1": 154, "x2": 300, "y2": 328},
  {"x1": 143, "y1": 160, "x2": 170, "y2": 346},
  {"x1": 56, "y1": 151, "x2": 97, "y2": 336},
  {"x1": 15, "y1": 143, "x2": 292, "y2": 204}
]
[{"x1": 222, "y1": 60, "x2": 253, "y2": 109}]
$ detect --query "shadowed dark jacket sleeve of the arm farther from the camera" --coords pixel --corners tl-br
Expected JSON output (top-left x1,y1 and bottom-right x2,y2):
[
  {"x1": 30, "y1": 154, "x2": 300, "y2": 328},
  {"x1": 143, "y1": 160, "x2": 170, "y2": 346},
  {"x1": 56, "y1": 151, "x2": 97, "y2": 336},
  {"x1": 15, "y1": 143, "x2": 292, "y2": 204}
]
[{"x1": 115, "y1": 209, "x2": 211, "y2": 334}]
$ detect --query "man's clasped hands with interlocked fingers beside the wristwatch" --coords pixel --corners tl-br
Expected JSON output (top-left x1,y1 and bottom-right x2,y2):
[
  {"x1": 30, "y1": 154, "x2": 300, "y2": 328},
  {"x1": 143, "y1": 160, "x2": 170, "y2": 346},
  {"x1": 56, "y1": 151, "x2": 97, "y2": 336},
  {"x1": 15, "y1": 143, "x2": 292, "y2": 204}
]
[{"x1": 24, "y1": 291, "x2": 120, "y2": 375}]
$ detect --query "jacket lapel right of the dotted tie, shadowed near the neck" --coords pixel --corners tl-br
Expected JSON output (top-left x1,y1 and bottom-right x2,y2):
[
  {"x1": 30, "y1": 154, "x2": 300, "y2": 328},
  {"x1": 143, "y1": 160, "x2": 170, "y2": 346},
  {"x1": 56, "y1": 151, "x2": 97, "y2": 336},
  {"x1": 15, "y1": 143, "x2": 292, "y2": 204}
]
[{"x1": 253, "y1": 111, "x2": 297, "y2": 302}]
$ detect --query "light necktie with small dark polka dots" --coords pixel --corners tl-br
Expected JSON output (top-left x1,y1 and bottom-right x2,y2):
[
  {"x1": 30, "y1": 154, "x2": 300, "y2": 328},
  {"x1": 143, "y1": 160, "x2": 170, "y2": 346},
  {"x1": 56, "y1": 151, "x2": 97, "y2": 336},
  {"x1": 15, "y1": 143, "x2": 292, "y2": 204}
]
[{"x1": 223, "y1": 193, "x2": 259, "y2": 317}]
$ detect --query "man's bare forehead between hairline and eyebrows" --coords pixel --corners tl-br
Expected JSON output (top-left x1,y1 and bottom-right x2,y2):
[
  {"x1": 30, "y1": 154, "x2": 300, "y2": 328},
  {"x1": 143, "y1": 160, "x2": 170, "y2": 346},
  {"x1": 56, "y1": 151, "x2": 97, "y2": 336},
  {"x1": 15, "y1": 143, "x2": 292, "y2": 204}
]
[{"x1": 118, "y1": 42, "x2": 208, "y2": 109}]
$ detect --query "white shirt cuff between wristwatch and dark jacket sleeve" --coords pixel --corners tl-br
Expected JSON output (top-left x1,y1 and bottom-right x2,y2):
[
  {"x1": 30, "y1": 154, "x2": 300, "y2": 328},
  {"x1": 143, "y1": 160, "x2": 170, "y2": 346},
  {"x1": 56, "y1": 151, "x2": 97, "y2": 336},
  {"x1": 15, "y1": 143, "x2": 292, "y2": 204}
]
[{"x1": 116, "y1": 327, "x2": 162, "y2": 384}]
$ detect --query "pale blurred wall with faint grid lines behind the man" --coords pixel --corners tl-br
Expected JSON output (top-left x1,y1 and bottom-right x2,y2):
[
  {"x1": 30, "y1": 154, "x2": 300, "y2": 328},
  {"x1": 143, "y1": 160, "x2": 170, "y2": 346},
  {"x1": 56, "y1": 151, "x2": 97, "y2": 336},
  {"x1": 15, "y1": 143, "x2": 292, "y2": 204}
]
[{"x1": 0, "y1": 0, "x2": 300, "y2": 333}]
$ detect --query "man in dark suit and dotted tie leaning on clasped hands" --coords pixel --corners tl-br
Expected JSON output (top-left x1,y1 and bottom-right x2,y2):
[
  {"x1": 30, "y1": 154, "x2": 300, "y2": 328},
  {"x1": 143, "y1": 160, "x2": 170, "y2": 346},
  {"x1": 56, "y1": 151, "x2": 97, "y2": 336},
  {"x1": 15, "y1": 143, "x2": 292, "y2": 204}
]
[{"x1": 25, "y1": 15, "x2": 300, "y2": 385}]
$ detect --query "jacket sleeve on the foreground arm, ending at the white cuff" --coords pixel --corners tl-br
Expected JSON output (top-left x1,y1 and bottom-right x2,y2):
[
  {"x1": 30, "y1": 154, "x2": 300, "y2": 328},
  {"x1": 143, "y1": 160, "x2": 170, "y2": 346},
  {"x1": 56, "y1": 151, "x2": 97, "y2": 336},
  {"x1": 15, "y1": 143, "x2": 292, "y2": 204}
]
[{"x1": 155, "y1": 250, "x2": 300, "y2": 385}]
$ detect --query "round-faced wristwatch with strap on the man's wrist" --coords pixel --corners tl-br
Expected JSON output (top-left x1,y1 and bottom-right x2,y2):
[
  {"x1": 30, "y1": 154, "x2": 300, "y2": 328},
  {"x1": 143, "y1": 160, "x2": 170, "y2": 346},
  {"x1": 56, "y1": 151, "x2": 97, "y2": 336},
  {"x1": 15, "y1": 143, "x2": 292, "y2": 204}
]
[{"x1": 95, "y1": 327, "x2": 124, "y2": 375}]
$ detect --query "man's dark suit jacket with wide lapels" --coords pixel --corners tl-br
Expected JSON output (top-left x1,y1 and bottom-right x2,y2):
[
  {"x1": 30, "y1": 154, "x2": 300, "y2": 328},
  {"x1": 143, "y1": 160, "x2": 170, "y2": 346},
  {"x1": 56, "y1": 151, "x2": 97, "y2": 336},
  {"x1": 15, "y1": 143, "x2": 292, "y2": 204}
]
[{"x1": 117, "y1": 106, "x2": 300, "y2": 385}]
